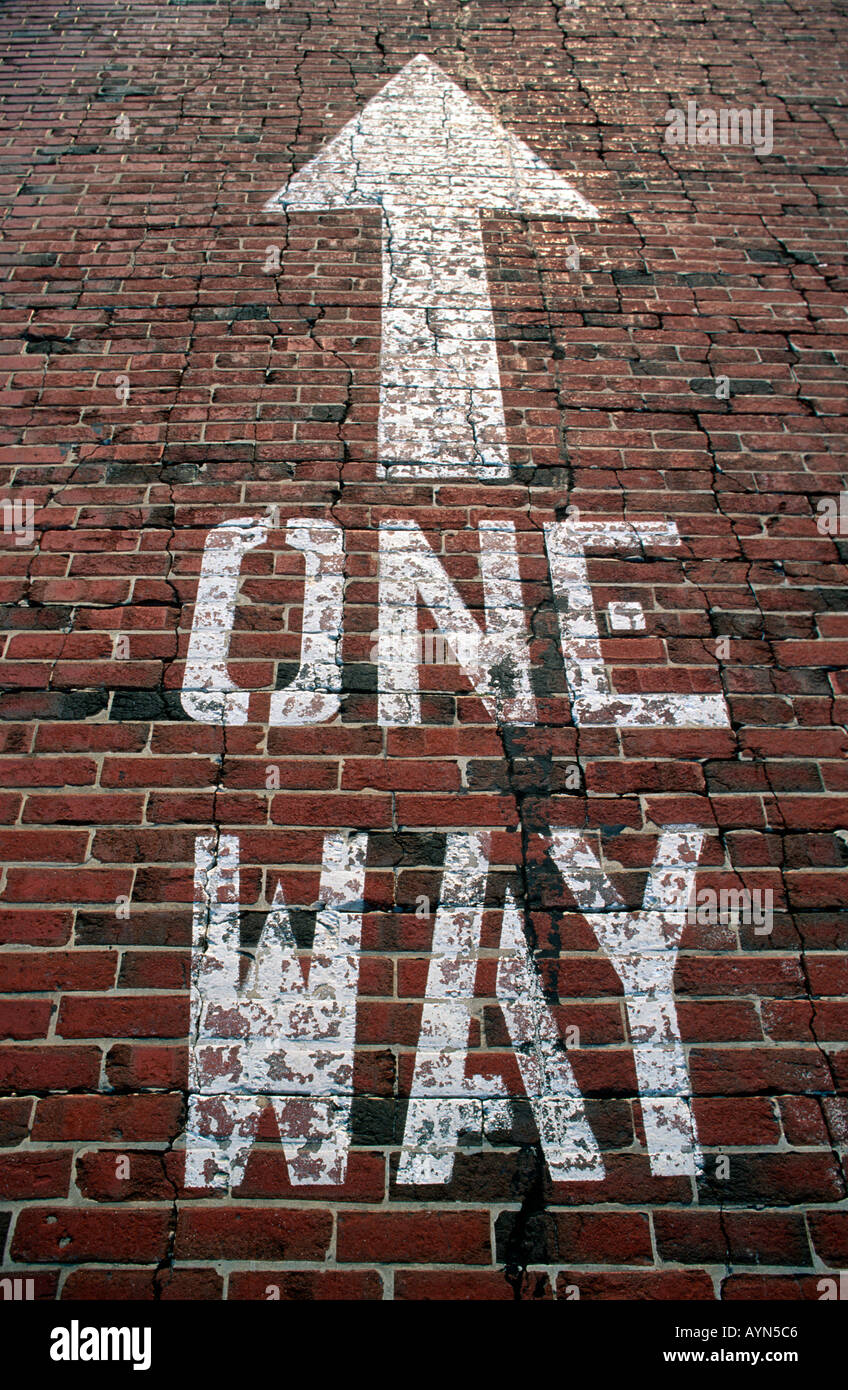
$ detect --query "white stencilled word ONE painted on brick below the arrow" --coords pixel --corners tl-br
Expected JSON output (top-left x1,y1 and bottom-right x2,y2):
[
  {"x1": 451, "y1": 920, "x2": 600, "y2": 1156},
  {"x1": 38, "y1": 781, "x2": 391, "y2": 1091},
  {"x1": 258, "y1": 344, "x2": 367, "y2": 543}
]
[{"x1": 181, "y1": 517, "x2": 728, "y2": 728}]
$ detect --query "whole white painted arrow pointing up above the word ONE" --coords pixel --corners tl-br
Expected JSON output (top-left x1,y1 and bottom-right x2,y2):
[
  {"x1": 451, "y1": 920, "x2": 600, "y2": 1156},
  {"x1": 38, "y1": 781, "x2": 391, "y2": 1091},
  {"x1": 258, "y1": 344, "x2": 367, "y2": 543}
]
[{"x1": 267, "y1": 54, "x2": 598, "y2": 478}]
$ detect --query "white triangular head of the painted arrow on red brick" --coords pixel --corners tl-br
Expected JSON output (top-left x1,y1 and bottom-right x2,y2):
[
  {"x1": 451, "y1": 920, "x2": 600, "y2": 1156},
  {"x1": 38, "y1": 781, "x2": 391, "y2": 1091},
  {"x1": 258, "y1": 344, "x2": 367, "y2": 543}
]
[{"x1": 267, "y1": 54, "x2": 598, "y2": 217}]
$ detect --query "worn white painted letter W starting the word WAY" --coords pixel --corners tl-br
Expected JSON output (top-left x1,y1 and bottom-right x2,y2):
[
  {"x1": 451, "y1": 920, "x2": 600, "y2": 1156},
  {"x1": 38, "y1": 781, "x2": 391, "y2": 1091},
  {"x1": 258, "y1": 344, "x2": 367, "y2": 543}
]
[{"x1": 185, "y1": 833, "x2": 367, "y2": 1188}]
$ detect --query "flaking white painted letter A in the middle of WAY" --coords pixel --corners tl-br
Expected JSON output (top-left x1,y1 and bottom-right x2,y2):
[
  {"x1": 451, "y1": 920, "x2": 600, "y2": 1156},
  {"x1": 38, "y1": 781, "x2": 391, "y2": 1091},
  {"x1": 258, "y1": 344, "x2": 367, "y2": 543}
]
[{"x1": 398, "y1": 833, "x2": 603, "y2": 1184}]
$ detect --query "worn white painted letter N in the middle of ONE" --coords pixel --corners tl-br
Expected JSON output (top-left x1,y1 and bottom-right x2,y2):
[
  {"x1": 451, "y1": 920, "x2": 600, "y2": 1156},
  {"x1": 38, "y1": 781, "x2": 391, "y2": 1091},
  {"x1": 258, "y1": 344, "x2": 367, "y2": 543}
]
[{"x1": 378, "y1": 520, "x2": 535, "y2": 724}]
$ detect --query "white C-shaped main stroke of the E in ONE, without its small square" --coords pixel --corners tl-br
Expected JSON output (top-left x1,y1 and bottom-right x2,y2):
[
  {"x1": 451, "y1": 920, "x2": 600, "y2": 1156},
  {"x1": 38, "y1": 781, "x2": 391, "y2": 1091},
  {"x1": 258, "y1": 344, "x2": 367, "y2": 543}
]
[{"x1": 545, "y1": 517, "x2": 730, "y2": 728}]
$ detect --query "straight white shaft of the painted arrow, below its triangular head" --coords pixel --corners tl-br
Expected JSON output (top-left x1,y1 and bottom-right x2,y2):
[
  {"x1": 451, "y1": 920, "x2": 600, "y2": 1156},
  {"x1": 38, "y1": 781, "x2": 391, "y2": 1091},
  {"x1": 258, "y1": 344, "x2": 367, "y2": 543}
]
[{"x1": 378, "y1": 206, "x2": 509, "y2": 478}]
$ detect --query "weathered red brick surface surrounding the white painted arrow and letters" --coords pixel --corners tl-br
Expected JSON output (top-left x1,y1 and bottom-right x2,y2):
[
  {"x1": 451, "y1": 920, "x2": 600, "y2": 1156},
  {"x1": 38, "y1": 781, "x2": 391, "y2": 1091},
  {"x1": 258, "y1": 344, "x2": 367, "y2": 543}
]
[{"x1": 0, "y1": 0, "x2": 848, "y2": 1300}]
